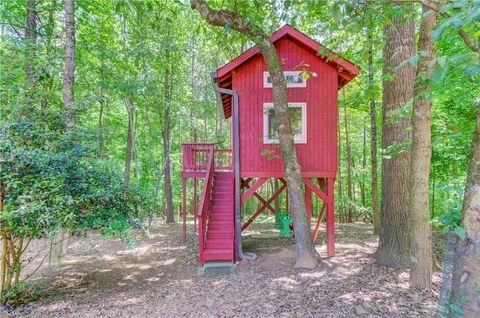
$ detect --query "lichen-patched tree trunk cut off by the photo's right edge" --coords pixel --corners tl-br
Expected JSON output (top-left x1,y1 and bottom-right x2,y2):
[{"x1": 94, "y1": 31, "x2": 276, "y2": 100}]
[{"x1": 450, "y1": 95, "x2": 480, "y2": 318}]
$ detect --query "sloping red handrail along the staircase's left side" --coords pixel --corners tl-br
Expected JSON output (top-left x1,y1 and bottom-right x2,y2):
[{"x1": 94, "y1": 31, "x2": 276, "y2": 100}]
[{"x1": 198, "y1": 145, "x2": 215, "y2": 265}]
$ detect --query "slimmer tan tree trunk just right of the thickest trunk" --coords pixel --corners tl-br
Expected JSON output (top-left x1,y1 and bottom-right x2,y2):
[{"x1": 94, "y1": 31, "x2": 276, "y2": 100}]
[{"x1": 410, "y1": 6, "x2": 437, "y2": 289}]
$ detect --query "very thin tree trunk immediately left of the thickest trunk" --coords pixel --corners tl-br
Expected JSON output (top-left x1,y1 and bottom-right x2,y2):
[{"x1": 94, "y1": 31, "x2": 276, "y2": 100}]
[{"x1": 368, "y1": 29, "x2": 380, "y2": 234}]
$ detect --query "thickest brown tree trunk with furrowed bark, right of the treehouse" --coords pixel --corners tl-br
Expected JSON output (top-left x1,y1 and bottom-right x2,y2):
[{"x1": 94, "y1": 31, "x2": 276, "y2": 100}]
[{"x1": 375, "y1": 8, "x2": 415, "y2": 267}]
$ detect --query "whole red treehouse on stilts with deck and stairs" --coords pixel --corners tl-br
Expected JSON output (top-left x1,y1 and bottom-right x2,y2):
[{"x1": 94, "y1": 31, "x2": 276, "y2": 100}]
[{"x1": 182, "y1": 25, "x2": 359, "y2": 265}]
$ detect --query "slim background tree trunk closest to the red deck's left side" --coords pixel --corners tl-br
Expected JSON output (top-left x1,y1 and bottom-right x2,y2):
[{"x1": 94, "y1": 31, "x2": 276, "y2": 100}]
[{"x1": 163, "y1": 65, "x2": 175, "y2": 223}]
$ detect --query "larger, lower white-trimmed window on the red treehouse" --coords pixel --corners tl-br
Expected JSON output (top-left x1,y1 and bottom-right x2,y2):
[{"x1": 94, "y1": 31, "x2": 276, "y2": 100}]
[{"x1": 263, "y1": 103, "x2": 307, "y2": 144}]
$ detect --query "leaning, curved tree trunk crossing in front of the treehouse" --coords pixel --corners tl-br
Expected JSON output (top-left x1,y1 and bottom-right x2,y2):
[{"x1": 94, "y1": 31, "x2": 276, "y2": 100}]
[{"x1": 190, "y1": 0, "x2": 317, "y2": 268}]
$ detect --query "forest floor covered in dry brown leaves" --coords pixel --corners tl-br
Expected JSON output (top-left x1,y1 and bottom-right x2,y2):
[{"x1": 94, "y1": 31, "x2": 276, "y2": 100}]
[{"x1": 9, "y1": 224, "x2": 440, "y2": 318}]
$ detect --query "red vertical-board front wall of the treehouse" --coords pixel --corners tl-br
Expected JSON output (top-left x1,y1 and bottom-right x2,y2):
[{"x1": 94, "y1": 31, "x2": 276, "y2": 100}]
[{"x1": 232, "y1": 37, "x2": 338, "y2": 177}]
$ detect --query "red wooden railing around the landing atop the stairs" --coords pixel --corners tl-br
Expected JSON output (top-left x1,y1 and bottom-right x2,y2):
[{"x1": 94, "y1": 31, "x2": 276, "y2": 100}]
[{"x1": 182, "y1": 143, "x2": 233, "y2": 172}]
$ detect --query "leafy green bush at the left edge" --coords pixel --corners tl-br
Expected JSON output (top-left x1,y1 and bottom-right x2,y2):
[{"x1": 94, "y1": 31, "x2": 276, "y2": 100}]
[{"x1": 0, "y1": 114, "x2": 148, "y2": 301}]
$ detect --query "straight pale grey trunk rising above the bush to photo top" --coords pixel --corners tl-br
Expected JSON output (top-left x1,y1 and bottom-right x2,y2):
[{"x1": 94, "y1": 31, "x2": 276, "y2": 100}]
[{"x1": 63, "y1": 0, "x2": 75, "y2": 131}]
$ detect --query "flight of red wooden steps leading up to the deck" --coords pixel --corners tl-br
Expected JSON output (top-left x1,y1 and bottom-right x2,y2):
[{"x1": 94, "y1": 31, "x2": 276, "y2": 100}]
[{"x1": 203, "y1": 172, "x2": 234, "y2": 262}]
